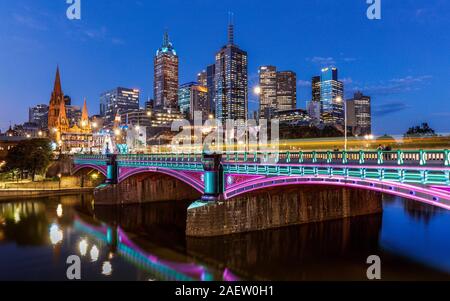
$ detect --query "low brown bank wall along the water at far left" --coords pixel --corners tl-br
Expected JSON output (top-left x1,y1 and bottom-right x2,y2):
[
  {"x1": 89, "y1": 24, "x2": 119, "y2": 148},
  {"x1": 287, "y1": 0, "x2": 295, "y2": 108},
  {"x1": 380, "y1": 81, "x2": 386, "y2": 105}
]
[{"x1": 0, "y1": 187, "x2": 94, "y2": 202}]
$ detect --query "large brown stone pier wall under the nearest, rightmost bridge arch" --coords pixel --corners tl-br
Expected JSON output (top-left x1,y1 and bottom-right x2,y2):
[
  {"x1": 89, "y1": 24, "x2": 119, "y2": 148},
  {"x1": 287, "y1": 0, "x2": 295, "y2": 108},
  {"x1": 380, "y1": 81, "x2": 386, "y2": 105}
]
[{"x1": 186, "y1": 186, "x2": 382, "y2": 237}]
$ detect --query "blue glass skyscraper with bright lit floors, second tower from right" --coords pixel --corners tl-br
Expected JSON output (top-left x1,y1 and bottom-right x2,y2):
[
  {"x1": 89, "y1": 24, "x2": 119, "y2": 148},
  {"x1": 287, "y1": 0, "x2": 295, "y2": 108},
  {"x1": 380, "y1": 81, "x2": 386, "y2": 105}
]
[{"x1": 320, "y1": 67, "x2": 344, "y2": 125}]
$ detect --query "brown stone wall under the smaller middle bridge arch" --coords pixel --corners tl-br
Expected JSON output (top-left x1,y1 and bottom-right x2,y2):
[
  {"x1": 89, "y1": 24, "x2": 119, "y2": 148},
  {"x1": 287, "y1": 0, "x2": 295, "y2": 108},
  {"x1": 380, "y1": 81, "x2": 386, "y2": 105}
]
[{"x1": 94, "y1": 169, "x2": 202, "y2": 204}]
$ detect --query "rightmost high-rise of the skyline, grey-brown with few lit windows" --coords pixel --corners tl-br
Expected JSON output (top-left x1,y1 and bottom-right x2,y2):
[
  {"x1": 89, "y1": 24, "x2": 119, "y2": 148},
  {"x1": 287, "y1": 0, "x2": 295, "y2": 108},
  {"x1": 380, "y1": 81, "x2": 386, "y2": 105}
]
[{"x1": 347, "y1": 91, "x2": 372, "y2": 135}]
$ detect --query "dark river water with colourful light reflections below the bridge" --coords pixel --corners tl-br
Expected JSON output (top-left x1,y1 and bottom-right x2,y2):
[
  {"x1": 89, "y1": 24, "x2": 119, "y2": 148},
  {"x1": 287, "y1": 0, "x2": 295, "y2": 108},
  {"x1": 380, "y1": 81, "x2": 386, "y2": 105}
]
[{"x1": 0, "y1": 194, "x2": 450, "y2": 281}]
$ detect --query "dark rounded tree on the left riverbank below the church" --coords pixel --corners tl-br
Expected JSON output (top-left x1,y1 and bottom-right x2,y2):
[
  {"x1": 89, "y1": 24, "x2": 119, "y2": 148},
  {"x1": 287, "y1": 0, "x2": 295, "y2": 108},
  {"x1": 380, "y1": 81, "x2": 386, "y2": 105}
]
[{"x1": 6, "y1": 139, "x2": 52, "y2": 181}]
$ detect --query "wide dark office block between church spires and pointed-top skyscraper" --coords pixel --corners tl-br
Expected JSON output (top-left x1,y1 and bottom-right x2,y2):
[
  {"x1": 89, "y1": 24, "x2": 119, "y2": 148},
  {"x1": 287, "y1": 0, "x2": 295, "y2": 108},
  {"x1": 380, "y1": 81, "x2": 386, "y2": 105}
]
[{"x1": 100, "y1": 87, "x2": 139, "y2": 126}]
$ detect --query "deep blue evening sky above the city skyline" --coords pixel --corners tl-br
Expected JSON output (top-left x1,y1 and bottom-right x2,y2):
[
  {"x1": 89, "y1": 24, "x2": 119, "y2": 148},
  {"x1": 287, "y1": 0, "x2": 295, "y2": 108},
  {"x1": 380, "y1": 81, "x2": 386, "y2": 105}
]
[{"x1": 0, "y1": 0, "x2": 450, "y2": 134}]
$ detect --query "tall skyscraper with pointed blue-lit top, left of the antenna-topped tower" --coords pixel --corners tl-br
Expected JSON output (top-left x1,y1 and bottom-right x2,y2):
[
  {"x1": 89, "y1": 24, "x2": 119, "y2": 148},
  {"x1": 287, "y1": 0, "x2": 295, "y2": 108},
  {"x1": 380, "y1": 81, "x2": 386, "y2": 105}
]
[{"x1": 153, "y1": 32, "x2": 178, "y2": 110}]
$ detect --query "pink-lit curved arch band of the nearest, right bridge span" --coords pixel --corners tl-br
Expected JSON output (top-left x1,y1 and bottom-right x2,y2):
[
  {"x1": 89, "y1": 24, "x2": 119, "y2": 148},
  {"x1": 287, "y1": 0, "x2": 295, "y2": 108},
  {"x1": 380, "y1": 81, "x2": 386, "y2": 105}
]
[{"x1": 224, "y1": 176, "x2": 450, "y2": 210}]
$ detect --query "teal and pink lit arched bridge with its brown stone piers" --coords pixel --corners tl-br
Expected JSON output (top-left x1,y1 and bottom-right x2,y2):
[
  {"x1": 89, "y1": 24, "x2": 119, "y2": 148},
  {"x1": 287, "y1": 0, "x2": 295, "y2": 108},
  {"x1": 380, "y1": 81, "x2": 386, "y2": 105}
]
[{"x1": 74, "y1": 150, "x2": 450, "y2": 237}]
